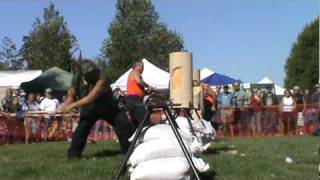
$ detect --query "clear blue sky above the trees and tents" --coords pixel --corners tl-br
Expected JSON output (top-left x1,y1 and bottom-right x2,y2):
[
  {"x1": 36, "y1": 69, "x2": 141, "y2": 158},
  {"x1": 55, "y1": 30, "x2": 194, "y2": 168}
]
[{"x1": 0, "y1": 0, "x2": 319, "y2": 85}]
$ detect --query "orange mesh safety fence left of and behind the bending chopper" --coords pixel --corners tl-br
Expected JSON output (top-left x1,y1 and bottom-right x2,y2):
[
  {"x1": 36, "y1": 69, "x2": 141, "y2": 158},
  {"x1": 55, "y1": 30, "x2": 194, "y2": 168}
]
[{"x1": 0, "y1": 111, "x2": 117, "y2": 144}]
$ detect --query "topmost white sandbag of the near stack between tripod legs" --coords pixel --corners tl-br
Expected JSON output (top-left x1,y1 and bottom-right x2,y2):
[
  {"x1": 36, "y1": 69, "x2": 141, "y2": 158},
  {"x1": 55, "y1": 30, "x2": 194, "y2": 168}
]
[{"x1": 141, "y1": 124, "x2": 192, "y2": 144}]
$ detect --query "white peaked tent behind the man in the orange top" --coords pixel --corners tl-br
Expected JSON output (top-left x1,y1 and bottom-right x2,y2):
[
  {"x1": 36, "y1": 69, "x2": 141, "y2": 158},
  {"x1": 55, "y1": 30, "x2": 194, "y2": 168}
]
[{"x1": 111, "y1": 59, "x2": 170, "y2": 91}]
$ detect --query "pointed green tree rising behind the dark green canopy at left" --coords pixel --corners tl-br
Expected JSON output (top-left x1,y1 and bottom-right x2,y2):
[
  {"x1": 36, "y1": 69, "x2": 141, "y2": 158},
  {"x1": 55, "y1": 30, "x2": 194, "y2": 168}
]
[{"x1": 21, "y1": 3, "x2": 78, "y2": 71}]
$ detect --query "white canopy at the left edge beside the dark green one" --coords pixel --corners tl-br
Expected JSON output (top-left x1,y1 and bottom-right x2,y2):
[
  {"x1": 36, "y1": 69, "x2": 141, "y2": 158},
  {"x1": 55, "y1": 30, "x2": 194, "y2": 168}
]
[{"x1": 0, "y1": 70, "x2": 42, "y2": 88}]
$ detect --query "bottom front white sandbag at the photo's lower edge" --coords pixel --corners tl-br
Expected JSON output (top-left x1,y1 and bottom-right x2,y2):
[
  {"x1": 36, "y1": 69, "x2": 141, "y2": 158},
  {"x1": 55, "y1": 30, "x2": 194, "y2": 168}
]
[{"x1": 130, "y1": 157, "x2": 191, "y2": 180}]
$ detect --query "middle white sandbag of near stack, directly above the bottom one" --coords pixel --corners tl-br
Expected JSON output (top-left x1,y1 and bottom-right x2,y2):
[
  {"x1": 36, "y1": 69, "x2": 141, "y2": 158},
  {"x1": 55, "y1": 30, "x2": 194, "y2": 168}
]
[{"x1": 128, "y1": 138, "x2": 190, "y2": 167}]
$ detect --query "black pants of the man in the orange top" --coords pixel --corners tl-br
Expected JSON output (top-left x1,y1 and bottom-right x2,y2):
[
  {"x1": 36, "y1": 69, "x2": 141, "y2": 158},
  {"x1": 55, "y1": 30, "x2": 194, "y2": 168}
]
[{"x1": 126, "y1": 95, "x2": 152, "y2": 127}]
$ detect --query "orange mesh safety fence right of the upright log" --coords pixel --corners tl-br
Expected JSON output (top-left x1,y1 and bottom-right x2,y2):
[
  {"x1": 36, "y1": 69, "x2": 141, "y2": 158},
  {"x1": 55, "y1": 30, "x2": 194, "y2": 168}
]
[{"x1": 211, "y1": 104, "x2": 319, "y2": 136}]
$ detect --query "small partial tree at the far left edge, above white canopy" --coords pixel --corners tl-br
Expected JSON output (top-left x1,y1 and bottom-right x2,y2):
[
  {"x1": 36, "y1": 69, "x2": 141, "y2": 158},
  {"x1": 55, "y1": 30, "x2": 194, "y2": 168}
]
[{"x1": 0, "y1": 37, "x2": 24, "y2": 70}]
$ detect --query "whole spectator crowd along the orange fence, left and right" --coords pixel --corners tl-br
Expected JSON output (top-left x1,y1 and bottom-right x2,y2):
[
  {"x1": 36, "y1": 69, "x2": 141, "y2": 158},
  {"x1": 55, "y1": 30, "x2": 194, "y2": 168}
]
[{"x1": 0, "y1": 83, "x2": 320, "y2": 144}]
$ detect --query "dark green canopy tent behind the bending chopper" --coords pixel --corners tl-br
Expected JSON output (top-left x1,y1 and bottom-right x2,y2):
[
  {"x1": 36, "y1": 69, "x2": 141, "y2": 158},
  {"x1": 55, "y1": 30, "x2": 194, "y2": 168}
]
[{"x1": 20, "y1": 67, "x2": 72, "y2": 92}]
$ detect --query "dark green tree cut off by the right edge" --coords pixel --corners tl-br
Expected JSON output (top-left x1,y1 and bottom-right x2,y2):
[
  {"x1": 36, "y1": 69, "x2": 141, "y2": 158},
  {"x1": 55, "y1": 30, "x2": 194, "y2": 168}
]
[{"x1": 285, "y1": 19, "x2": 319, "y2": 89}]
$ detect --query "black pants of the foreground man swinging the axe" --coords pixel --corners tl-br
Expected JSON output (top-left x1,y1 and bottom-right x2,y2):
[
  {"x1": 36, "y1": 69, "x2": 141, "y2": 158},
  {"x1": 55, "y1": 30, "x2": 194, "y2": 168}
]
[{"x1": 68, "y1": 107, "x2": 135, "y2": 159}]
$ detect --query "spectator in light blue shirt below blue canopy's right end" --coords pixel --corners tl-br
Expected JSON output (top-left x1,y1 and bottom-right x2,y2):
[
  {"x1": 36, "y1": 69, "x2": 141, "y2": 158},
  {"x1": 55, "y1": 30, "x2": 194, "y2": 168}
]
[{"x1": 233, "y1": 82, "x2": 250, "y2": 135}]
